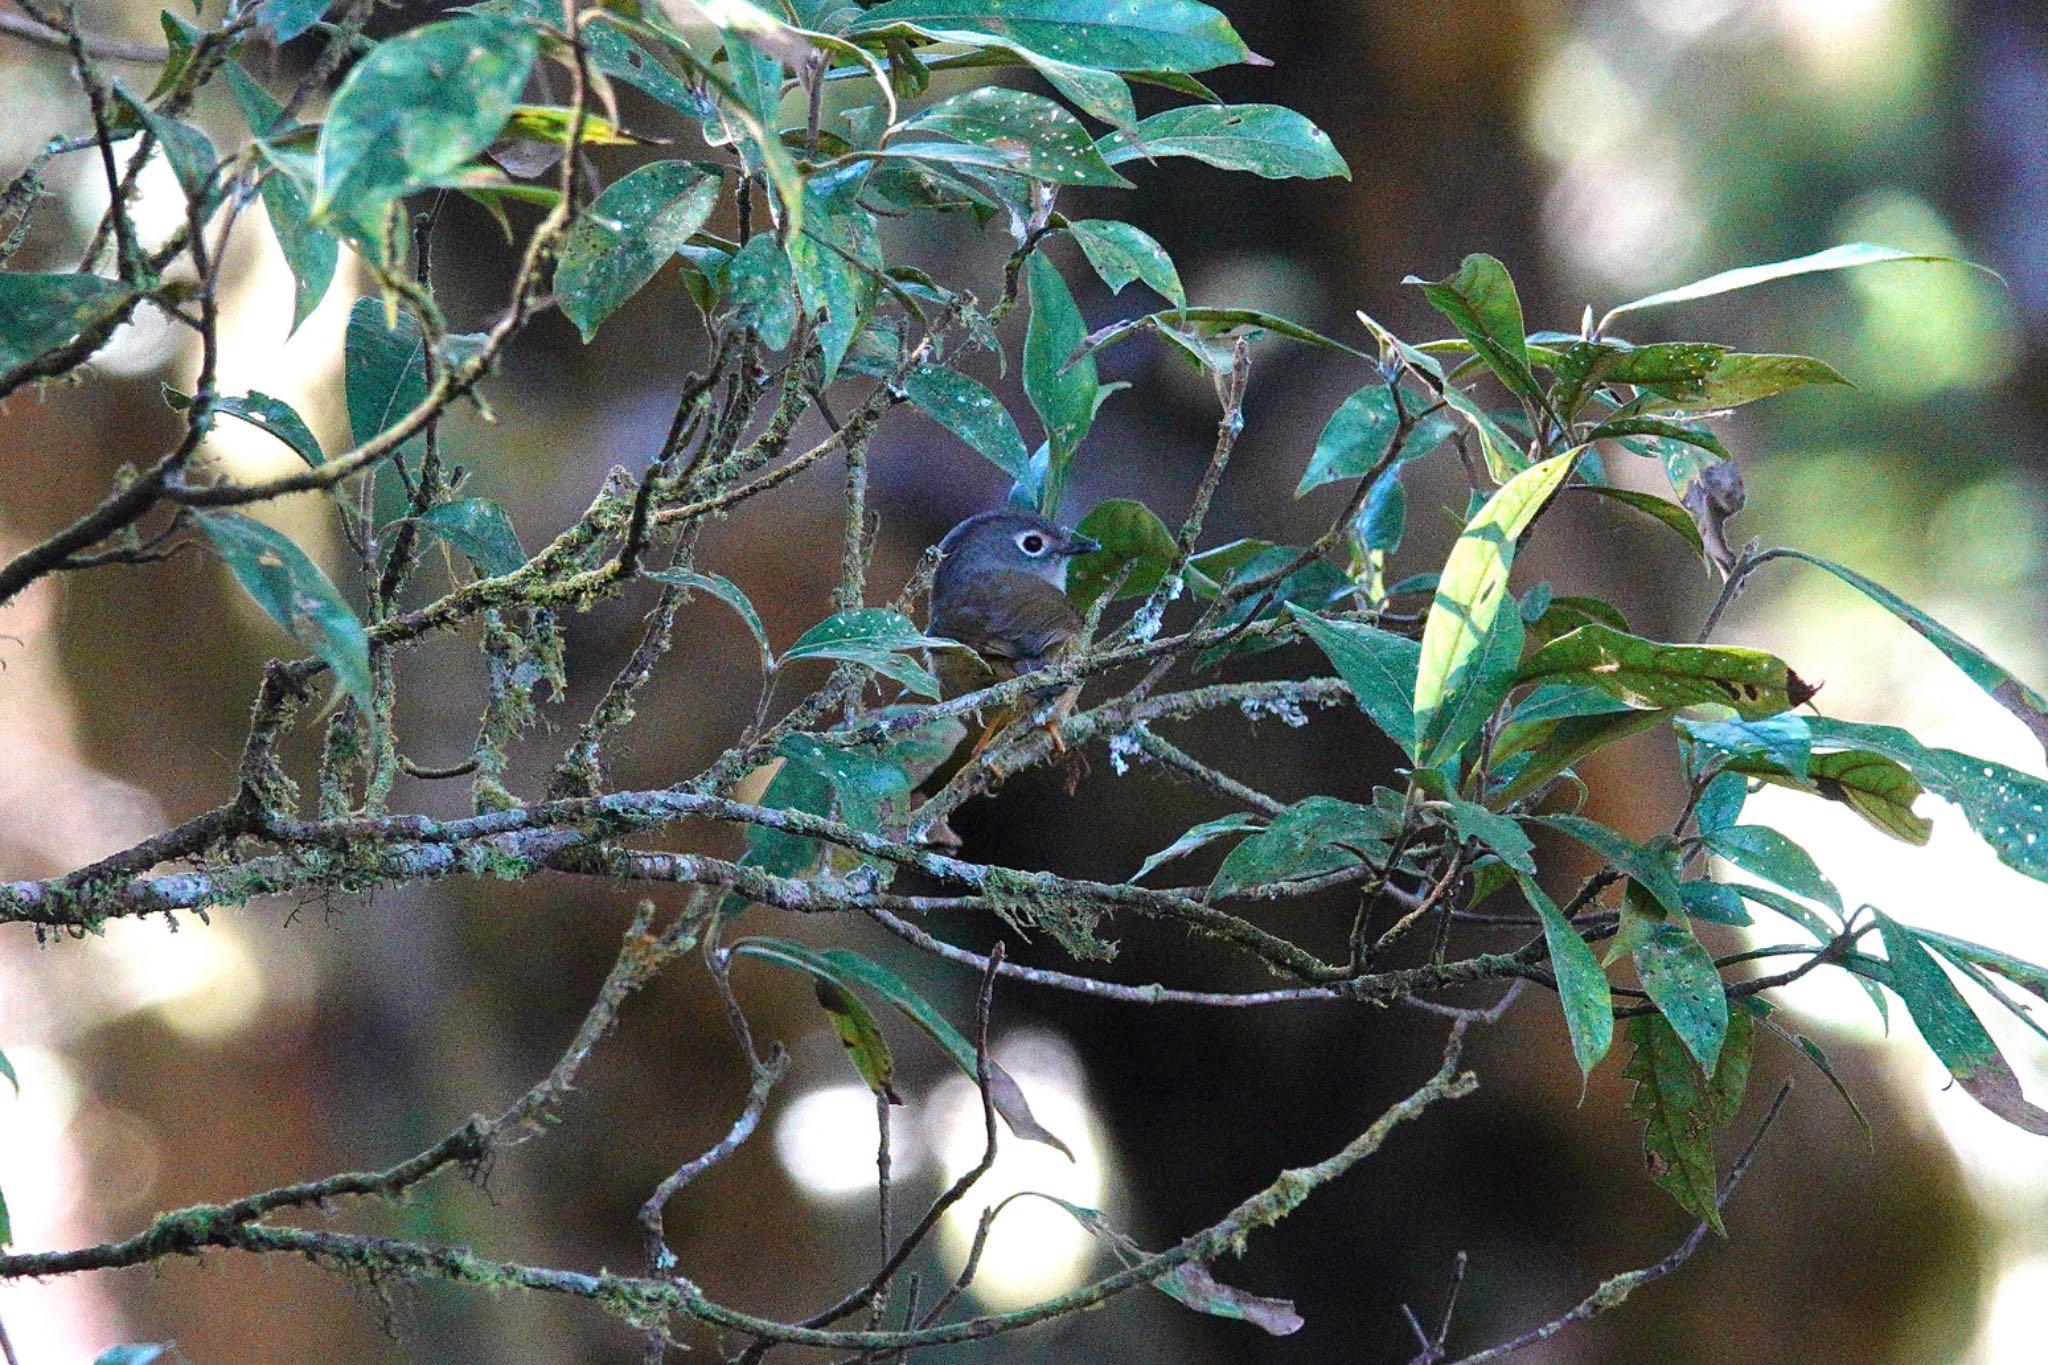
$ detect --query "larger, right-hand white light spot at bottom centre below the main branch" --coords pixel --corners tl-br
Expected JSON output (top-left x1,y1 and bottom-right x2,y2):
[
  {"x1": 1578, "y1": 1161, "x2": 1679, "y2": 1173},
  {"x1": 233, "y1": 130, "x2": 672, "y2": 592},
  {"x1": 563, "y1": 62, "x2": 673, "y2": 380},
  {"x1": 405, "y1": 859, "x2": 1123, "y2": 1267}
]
[{"x1": 930, "y1": 1031, "x2": 1108, "y2": 1310}]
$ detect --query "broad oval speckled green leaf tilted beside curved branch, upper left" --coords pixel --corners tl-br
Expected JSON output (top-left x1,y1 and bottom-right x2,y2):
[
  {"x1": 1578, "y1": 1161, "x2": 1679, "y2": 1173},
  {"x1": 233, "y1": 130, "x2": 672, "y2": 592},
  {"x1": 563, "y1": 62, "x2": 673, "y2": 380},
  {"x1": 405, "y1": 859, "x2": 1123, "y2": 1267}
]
[{"x1": 555, "y1": 162, "x2": 719, "y2": 342}]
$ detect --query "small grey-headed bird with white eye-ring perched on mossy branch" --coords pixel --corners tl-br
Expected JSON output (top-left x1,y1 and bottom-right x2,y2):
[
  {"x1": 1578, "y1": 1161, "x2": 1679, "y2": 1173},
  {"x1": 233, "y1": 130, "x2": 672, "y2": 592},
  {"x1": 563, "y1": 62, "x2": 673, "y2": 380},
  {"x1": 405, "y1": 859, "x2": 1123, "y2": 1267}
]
[{"x1": 922, "y1": 510, "x2": 1102, "y2": 810}]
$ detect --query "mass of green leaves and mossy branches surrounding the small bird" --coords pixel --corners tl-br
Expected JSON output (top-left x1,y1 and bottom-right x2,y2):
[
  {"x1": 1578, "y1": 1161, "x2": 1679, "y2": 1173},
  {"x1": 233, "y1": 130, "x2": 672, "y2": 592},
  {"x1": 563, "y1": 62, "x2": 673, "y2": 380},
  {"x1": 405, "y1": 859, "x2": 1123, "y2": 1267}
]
[{"x1": 0, "y1": 0, "x2": 2048, "y2": 1345}]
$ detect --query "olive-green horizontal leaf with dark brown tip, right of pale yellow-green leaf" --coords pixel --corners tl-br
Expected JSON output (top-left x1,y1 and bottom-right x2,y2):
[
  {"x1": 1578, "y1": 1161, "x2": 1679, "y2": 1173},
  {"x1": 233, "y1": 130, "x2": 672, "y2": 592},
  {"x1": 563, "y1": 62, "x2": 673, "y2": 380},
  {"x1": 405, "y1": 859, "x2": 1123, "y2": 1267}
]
[{"x1": 1522, "y1": 624, "x2": 1815, "y2": 720}]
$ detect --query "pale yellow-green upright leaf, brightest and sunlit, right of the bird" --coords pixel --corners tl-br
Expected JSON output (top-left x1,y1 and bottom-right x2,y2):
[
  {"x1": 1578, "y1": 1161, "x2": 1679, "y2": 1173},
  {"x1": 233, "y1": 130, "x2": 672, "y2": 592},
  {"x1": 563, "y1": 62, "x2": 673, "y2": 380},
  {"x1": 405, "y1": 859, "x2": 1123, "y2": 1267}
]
[{"x1": 1415, "y1": 450, "x2": 1577, "y2": 767}]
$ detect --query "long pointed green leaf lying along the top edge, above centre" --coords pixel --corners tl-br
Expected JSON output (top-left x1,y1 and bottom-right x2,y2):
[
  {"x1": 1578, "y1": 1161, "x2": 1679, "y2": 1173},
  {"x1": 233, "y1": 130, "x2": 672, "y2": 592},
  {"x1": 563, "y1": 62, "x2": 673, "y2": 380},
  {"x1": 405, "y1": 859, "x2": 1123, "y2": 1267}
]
[{"x1": 848, "y1": 0, "x2": 1251, "y2": 72}]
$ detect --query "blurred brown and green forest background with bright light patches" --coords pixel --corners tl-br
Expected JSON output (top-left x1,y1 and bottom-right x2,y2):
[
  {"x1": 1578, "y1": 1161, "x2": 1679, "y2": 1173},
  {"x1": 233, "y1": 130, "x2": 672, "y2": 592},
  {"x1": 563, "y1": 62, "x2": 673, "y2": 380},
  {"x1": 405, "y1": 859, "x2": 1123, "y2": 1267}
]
[{"x1": 0, "y1": 0, "x2": 2048, "y2": 1365}]
